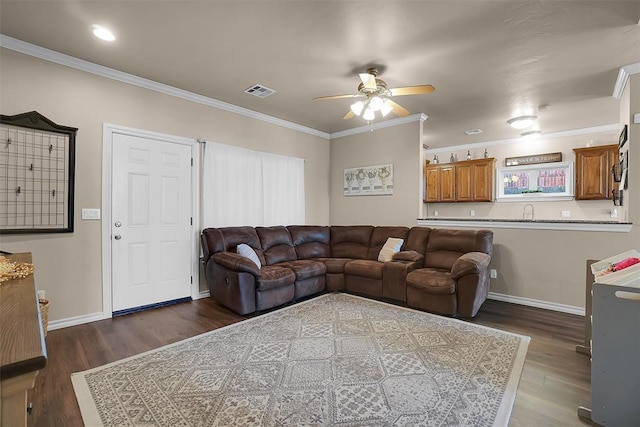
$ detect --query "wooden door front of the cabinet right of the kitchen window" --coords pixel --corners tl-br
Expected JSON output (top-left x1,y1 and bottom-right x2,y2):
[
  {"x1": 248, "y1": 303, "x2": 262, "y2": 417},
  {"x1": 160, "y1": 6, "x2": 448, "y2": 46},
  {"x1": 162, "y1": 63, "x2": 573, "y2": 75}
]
[{"x1": 576, "y1": 149, "x2": 610, "y2": 200}]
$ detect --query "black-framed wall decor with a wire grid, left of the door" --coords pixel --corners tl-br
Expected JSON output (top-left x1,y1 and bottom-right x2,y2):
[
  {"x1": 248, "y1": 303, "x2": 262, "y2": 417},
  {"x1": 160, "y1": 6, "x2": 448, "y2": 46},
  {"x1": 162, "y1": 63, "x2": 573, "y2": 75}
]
[{"x1": 0, "y1": 111, "x2": 78, "y2": 234}]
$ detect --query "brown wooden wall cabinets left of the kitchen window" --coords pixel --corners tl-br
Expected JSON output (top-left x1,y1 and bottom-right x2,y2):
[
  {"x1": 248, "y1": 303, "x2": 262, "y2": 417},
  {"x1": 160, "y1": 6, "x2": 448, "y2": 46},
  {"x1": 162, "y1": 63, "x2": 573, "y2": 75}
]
[{"x1": 424, "y1": 157, "x2": 496, "y2": 203}]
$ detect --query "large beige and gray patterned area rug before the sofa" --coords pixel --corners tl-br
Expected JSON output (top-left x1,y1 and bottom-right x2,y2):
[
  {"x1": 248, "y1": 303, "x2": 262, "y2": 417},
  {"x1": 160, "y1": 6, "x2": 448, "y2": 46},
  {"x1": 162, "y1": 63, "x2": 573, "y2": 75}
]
[{"x1": 72, "y1": 293, "x2": 529, "y2": 427}]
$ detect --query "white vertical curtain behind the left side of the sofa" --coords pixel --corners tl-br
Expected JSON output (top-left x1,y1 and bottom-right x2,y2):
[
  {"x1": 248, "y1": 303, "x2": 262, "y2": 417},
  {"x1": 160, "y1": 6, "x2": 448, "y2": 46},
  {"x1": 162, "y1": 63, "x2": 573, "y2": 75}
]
[{"x1": 202, "y1": 142, "x2": 305, "y2": 227}]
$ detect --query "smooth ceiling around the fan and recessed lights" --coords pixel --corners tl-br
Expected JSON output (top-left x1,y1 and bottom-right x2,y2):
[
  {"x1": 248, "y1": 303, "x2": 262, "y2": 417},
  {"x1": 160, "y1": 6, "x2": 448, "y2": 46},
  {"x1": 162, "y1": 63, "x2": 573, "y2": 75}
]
[{"x1": 0, "y1": 0, "x2": 640, "y2": 147}]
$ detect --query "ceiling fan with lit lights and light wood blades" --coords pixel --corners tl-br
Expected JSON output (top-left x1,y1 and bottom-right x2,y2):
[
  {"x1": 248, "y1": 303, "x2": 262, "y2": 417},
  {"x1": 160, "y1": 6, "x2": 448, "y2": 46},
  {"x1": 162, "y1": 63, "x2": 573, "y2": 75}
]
[{"x1": 313, "y1": 68, "x2": 436, "y2": 120}]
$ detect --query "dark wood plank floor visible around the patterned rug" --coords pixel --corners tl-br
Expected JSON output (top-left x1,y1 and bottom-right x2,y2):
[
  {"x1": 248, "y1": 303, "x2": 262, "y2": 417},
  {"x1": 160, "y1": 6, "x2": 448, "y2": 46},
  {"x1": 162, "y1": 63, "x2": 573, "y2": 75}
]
[{"x1": 29, "y1": 298, "x2": 590, "y2": 427}]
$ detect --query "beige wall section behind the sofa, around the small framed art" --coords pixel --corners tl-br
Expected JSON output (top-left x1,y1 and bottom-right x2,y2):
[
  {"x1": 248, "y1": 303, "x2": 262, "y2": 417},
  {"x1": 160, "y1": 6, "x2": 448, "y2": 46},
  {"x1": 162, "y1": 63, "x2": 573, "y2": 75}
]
[{"x1": 330, "y1": 122, "x2": 422, "y2": 226}]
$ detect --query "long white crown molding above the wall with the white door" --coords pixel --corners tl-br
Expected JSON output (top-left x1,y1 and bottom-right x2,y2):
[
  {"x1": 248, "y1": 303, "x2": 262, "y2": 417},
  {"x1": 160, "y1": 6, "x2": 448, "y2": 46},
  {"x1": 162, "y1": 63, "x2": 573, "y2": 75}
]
[{"x1": 0, "y1": 34, "x2": 330, "y2": 139}]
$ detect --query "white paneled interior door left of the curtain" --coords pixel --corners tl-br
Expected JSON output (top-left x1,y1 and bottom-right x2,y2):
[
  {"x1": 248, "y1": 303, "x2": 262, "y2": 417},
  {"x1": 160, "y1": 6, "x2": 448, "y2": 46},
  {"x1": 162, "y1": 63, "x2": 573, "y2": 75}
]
[{"x1": 111, "y1": 133, "x2": 192, "y2": 311}]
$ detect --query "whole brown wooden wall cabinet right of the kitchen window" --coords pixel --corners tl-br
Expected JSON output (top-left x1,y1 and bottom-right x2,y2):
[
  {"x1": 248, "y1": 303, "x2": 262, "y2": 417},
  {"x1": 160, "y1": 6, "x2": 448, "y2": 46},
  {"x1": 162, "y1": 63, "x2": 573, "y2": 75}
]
[{"x1": 573, "y1": 144, "x2": 619, "y2": 200}]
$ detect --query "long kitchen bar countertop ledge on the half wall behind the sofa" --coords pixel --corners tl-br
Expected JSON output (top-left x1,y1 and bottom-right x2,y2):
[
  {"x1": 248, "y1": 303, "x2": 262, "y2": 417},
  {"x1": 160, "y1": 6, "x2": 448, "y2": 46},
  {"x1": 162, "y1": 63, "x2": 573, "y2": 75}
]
[{"x1": 418, "y1": 217, "x2": 633, "y2": 233}]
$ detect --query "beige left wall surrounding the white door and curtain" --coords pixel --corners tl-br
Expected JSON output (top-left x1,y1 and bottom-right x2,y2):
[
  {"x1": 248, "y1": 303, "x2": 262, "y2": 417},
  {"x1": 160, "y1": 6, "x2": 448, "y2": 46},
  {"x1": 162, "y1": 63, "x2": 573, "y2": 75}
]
[{"x1": 0, "y1": 49, "x2": 329, "y2": 321}]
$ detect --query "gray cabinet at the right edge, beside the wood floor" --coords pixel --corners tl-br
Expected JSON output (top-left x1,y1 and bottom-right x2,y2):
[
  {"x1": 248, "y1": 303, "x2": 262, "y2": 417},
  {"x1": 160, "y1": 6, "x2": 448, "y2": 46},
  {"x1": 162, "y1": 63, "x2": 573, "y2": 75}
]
[{"x1": 591, "y1": 279, "x2": 640, "y2": 426}]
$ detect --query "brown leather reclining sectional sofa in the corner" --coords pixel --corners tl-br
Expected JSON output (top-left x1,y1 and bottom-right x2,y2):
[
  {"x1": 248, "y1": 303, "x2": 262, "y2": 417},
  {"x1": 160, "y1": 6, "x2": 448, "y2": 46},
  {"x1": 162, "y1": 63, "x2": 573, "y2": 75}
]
[{"x1": 201, "y1": 225, "x2": 493, "y2": 317}]
